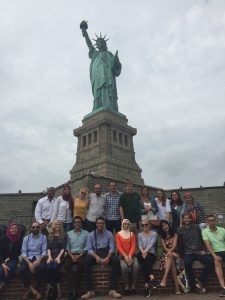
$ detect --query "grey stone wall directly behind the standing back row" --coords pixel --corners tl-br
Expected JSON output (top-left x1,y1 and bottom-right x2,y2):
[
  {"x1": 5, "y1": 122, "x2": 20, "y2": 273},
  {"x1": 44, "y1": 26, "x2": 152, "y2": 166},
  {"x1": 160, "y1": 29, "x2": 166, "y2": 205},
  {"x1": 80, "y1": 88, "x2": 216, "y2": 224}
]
[{"x1": 0, "y1": 174, "x2": 225, "y2": 224}]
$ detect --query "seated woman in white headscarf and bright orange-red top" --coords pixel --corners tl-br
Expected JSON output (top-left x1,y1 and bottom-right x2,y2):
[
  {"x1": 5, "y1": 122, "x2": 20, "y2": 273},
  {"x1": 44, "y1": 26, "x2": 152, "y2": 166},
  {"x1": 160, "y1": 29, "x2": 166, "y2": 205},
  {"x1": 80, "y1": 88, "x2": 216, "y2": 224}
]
[{"x1": 116, "y1": 219, "x2": 139, "y2": 295}]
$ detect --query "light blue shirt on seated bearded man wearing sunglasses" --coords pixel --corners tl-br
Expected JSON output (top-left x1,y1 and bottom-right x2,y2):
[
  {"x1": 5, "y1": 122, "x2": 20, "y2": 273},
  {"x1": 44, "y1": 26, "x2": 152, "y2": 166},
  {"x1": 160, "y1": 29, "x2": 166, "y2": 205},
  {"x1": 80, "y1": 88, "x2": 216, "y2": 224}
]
[{"x1": 21, "y1": 233, "x2": 47, "y2": 259}]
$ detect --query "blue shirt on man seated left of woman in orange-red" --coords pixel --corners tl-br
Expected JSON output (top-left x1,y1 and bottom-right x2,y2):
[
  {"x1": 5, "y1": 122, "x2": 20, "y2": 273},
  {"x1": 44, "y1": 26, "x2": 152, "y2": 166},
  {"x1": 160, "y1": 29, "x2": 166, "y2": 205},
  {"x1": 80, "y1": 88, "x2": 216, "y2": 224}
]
[{"x1": 86, "y1": 230, "x2": 115, "y2": 254}]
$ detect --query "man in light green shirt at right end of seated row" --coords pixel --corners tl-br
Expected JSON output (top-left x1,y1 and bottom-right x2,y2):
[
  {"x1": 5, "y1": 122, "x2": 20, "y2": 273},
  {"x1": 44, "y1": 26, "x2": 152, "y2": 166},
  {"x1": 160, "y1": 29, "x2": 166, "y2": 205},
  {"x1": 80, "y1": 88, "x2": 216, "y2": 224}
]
[{"x1": 202, "y1": 215, "x2": 225, "y2": 297}]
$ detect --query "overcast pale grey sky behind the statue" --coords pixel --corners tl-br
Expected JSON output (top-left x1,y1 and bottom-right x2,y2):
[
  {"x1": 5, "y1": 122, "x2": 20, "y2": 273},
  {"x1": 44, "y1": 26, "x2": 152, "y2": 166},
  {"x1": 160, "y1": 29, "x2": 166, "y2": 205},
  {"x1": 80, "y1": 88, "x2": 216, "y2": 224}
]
[{"x1": 0, "y1": 0, "x2": 225, "y2": 193}]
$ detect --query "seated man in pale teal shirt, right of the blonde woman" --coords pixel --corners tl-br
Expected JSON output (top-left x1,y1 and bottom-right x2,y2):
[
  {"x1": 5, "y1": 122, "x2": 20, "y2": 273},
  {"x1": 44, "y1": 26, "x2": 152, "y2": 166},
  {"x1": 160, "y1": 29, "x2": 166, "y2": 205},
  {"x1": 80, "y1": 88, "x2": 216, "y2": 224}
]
[{"x1": 64, "y1": 216, "x2": 89, "y2": 300}]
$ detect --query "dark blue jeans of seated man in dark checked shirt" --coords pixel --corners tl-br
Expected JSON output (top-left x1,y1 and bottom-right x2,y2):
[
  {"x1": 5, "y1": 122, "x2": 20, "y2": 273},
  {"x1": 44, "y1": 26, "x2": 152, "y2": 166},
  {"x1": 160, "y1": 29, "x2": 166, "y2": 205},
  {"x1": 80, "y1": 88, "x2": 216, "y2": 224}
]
[{"x1": 184, "y1": 253, "x2": 214, "y2": 289}]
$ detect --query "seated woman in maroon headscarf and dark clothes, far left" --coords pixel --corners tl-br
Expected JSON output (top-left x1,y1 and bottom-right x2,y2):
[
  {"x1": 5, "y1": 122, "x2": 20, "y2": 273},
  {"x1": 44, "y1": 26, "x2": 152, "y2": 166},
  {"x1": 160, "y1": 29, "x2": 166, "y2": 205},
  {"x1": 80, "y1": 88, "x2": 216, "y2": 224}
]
[{"x1": 0, "y1": 224, "x2": 22, "y2": 290}]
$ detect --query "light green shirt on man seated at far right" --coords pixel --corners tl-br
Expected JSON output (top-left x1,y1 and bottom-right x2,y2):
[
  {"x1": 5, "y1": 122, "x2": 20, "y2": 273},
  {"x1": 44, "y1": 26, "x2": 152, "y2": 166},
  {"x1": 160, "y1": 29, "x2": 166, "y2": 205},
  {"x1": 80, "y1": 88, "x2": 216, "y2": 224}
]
[{"x1": 202, "y1": 226, "x2": 225, "y2": 252}]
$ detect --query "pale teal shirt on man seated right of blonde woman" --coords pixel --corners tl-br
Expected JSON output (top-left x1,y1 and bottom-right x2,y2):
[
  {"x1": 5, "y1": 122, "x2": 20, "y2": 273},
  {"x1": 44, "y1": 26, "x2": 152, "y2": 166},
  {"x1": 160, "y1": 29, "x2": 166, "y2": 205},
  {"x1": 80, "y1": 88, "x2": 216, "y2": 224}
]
[{"x1": 66, "y1": 229, "x2": 89, "y2": 253}]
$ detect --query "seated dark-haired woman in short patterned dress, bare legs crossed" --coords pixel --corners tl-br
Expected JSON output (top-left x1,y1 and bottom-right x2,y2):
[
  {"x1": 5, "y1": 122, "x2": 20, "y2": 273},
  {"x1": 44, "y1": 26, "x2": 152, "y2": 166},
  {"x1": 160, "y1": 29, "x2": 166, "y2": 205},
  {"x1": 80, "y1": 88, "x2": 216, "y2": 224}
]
[{"x1": 159, "y1": 220, "x2": 181, "y2": 295}]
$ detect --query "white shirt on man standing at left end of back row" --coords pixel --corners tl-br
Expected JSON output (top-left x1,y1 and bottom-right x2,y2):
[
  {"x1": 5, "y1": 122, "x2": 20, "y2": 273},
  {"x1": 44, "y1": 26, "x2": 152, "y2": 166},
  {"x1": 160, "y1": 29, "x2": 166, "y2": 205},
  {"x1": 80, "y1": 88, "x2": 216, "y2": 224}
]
[{"x1": 34, "y1": 196, "x2": 56, "y2": 224}]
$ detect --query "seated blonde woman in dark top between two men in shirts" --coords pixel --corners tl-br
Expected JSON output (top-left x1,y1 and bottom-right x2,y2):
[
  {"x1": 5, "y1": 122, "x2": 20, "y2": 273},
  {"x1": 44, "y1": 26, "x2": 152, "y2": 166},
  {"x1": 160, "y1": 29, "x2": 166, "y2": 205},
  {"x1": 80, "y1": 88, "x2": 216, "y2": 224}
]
[{"x1": 46, "y1": 220, "x2": 67, "y2": 298}]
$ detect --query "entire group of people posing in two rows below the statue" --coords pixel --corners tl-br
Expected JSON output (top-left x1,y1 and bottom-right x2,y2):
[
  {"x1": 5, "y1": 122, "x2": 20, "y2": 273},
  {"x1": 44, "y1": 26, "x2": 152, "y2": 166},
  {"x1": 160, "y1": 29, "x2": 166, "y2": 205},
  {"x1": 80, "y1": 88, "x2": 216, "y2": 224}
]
[{"x1": 0, "y1": 181, "x2": 225, "y2": 300}]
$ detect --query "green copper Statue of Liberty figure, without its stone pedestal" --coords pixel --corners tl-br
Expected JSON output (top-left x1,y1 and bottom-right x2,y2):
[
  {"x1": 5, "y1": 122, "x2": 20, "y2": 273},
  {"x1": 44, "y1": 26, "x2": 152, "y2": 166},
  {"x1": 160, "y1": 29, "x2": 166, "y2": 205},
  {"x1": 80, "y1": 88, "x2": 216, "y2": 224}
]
[{"x1": 80, "y1": 21, "x2": 122, "y2": 113}]
